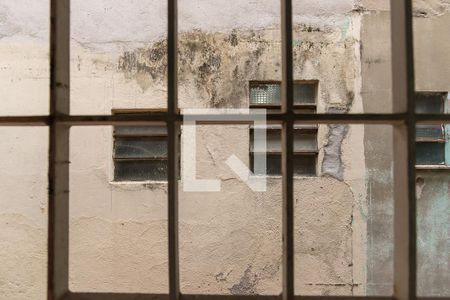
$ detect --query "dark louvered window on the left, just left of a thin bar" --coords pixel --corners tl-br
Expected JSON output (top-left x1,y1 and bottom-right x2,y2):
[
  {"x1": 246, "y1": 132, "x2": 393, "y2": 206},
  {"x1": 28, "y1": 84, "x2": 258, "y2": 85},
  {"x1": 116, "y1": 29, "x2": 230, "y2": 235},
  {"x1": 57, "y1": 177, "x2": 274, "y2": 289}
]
[{"x1": 113, "y1": 119, "x2": 167, "y2": 181}]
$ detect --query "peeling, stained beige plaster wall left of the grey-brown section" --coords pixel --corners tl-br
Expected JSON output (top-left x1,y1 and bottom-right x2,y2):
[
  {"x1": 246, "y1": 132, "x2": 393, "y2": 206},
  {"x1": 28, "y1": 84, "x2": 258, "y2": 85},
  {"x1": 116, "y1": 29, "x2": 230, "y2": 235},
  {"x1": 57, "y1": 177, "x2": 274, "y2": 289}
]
[{"x1": 0, "y1": 0, "x2": 448, "y2": 299}]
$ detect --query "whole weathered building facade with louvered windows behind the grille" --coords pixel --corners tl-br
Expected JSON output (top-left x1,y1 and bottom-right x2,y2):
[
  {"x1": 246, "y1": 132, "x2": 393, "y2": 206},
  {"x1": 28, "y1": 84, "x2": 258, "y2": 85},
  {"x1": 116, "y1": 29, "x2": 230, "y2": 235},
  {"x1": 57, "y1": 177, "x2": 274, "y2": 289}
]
[{"x1": 0, "y1": 0, "x2": 450, "y2": 299}]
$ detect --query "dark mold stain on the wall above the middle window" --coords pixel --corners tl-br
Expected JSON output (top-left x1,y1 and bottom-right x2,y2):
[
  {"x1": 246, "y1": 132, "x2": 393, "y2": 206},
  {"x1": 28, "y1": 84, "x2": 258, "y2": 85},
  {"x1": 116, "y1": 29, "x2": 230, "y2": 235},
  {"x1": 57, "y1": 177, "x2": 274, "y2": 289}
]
[{"x1": 117, "y1": 24, "x2": 356, "y2": 108}]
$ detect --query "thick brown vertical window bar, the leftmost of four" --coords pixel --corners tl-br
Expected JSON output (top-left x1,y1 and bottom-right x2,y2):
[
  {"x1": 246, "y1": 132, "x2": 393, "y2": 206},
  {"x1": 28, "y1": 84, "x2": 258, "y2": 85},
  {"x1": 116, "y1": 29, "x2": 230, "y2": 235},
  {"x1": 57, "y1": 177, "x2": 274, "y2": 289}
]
[{"x1": 47, "y1": 0, "x2": 70, "y2": 300}]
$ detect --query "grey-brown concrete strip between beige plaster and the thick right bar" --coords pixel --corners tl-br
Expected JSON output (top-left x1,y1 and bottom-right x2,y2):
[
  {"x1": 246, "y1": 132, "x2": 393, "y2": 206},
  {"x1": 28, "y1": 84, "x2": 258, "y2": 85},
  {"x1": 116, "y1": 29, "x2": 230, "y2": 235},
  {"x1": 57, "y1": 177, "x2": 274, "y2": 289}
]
[{"x1": 361, "y1": 7, "x2": 393, "y2": 295}]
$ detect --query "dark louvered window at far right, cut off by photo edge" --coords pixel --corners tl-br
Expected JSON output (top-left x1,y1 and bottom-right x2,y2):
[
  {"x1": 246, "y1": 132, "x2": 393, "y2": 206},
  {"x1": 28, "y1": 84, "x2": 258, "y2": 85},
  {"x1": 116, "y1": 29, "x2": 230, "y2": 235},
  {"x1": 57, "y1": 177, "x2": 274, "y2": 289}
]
[{"x1": 415, "y1": 92, "x2": 450, "y2": 166}]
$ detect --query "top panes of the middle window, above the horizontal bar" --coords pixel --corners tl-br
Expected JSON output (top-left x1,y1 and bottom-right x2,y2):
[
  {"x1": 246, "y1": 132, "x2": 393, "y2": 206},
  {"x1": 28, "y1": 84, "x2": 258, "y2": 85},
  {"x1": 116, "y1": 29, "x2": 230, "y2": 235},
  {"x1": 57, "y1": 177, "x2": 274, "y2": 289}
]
[{"x1": 250, "y1": 82, "x2": 317, "y2": 106}]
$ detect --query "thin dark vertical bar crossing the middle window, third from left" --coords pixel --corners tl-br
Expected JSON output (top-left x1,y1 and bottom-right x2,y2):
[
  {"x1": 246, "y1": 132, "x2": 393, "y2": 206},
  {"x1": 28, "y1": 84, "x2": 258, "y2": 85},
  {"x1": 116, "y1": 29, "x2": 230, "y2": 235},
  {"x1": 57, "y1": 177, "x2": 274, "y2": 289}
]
[{"x1": 281, "y1": 0, "x2": 294, "y2": 300}]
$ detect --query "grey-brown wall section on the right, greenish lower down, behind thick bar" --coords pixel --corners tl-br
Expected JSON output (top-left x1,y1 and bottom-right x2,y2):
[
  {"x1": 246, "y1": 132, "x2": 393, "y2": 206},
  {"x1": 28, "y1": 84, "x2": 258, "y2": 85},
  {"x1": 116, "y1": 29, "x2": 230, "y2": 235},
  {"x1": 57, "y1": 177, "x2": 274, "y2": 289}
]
[{"x1": 361, "y1": 0, "x2": 450, "y2": 296}]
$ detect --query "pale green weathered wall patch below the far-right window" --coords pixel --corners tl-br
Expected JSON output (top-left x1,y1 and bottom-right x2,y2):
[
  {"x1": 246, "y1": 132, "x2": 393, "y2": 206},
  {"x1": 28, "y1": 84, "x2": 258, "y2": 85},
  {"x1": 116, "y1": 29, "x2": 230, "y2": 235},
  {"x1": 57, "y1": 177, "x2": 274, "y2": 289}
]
[{"x1": 417, "y1": 170, "x2": 450, "y2": 296}]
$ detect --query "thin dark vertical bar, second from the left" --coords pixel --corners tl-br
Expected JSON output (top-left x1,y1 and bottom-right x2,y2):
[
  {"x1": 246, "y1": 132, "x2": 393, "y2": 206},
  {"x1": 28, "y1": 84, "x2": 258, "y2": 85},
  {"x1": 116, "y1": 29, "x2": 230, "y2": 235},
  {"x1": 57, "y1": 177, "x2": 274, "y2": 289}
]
[{"x1": 167, "y1": 0, "x2": 180, "y2": 300}]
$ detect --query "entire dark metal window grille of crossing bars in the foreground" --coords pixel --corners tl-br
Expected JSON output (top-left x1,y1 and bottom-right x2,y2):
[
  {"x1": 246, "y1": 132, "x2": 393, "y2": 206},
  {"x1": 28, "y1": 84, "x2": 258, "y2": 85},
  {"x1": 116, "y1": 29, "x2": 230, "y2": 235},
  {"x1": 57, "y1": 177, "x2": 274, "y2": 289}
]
[{"x1": 0, "y1": 0, "x2": 450, "y2": 300}]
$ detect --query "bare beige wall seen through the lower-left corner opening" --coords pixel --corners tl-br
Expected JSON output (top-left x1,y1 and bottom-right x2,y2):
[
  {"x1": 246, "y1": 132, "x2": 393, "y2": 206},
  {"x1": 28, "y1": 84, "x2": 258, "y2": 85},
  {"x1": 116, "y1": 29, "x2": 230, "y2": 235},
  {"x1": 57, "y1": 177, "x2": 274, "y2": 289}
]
[{"x1": 0, "y1": 127, "x2": 48, "y2": 300}]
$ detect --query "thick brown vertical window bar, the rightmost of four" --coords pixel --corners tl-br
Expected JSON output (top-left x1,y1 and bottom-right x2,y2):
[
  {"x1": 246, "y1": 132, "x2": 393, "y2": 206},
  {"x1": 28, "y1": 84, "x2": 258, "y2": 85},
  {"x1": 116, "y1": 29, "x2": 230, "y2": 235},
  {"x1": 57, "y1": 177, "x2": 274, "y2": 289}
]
[{"x1": 391, "y1": 0, "x2": 416, "y2": 300}]
